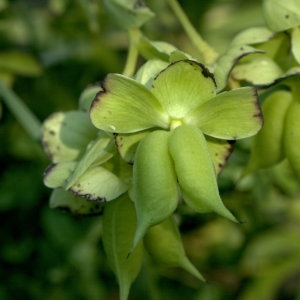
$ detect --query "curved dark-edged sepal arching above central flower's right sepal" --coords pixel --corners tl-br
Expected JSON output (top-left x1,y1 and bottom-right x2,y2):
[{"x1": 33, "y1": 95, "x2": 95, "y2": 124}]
[{"x1": 214, "y1": 45, "x2": 263, "y2": 92}]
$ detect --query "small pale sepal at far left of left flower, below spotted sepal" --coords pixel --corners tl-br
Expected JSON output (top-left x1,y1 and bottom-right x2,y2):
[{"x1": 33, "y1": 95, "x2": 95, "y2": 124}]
[{"x1": 44, "y1": 161, "x2": 77, "y2": 188}]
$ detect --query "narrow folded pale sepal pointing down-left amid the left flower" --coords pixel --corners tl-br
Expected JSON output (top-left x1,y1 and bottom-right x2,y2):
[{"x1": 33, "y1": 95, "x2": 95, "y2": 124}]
[{"x1": 65, "y1": 133, "x2": 113, "y2": 189}]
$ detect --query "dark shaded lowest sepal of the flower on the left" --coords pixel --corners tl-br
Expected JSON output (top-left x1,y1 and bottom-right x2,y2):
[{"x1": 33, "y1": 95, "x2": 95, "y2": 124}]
[{"x1": 49, "y1": 188, "x2": 104, "y2": 216}]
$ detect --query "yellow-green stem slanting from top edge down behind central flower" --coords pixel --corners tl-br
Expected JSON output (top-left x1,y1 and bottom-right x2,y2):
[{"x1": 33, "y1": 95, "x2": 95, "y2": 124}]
[{"x1": 167, "y1": 0, "x2": 218, "y2": 64}]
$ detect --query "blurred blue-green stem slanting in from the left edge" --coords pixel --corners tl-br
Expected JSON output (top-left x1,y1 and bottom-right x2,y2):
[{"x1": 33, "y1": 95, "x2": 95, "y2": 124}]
[{"x1": 0, "y1": 81, "x2": 41, "y2": 140}]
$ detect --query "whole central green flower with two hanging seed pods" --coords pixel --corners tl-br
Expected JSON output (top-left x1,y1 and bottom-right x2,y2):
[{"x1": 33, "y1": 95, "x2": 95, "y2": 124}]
[{"x1": 90, "y1": 60, "x2": 262, "y2": 244}]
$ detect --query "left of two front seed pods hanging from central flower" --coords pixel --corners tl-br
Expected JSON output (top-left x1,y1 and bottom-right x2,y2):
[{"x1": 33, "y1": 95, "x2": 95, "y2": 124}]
[{"x1": 132, "y1": 130, "x2": 179, "y2": 247}]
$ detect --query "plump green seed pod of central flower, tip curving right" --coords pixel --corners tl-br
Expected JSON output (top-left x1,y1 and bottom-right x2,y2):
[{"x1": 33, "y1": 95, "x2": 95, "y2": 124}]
[{"x1": 169, "y1": 125, "x2": 237, "y2": 222}]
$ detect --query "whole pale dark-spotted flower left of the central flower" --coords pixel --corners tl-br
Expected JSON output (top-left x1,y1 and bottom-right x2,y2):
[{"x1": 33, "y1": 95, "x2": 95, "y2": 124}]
[{"x1": 42, "y1": 110, "x2": 127, "y2": 215}]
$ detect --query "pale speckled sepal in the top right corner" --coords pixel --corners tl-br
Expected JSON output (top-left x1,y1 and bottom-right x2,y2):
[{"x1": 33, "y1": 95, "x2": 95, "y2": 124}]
[{"x1": 263, "y1": 0, "x2": 300, "y2": 31}]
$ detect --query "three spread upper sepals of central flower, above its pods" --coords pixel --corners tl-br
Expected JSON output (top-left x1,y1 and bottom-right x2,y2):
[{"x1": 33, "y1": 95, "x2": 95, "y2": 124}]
[{"x1": 90, "y1": 60, "x2": 261, "y2": 140}]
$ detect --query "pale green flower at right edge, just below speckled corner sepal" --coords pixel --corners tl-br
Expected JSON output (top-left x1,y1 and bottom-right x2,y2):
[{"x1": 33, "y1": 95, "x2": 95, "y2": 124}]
[{"x1": 231, "y1": 26, "x2": 300, "y2": 87}]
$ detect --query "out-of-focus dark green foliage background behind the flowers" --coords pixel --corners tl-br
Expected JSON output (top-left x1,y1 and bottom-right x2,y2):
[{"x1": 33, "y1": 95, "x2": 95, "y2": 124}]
[{"x1": 0, "y1": 0, "x2": 300, "y2": 300}]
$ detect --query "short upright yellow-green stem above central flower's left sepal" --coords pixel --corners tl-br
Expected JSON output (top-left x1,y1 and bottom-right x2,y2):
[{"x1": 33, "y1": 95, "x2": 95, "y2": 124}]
[{"x1": 122, "y1": 28, "x2": 141, "y2": 77}]
